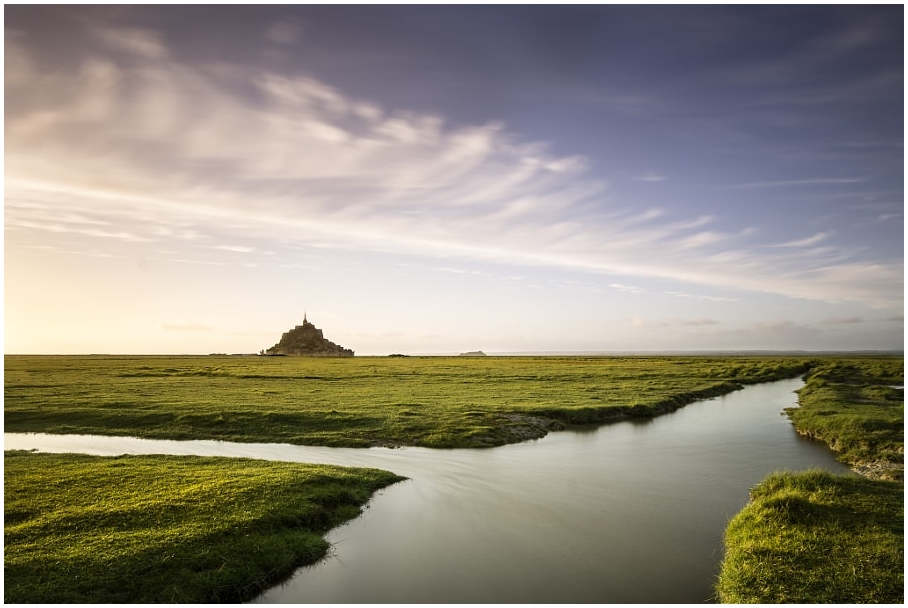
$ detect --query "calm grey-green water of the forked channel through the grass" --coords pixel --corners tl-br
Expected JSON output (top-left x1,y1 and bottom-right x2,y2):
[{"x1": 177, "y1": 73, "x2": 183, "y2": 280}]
[{"x1": 4, "y1": 380, "x2": 848, "y2": 603}]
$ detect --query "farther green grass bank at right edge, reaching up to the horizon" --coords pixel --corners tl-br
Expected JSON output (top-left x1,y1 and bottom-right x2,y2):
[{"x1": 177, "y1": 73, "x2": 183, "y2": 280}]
[{"x1": 787, "y1": 358, "x2": 905, "y2": 479}]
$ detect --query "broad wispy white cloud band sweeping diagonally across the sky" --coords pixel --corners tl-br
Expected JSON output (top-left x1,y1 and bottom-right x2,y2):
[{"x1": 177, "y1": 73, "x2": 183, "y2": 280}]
[{"x1": 5, "y1": 22, "x2": 903, "y2": 312}]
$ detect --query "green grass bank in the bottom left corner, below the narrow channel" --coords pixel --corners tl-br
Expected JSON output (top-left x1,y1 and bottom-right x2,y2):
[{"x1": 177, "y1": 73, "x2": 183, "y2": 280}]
[{"x1": 4, "y1": 451, "x2": 402, "y2": 603}]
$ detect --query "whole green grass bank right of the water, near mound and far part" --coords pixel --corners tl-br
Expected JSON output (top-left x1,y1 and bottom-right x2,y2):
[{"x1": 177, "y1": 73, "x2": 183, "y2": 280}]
[{"x1": 716, "y1": 357, "x2": 905, "y2": 604}]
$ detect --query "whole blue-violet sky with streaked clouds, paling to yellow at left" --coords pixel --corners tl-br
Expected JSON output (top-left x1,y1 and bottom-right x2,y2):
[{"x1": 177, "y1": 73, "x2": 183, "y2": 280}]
[{"x1": 3, "y1": 4, "x2": 905, "y2": 355}]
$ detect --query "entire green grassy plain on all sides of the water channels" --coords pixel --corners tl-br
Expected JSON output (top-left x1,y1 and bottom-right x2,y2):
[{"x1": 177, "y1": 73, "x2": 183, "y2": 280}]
[{"x1": 4, "y1": 355, "x2": 904, "y2": 603}]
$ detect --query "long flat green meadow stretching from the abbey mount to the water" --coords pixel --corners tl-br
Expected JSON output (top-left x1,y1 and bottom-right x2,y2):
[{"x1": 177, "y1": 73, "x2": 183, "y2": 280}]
[{"x1": 4, "y1": 356, "x2": 809, "y2": 448}]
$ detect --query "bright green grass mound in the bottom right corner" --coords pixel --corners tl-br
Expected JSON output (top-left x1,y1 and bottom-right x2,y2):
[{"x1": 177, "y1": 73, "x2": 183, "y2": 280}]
[{"x1": 716, "y1": 471, "x2": 905, "y2": 604}]
